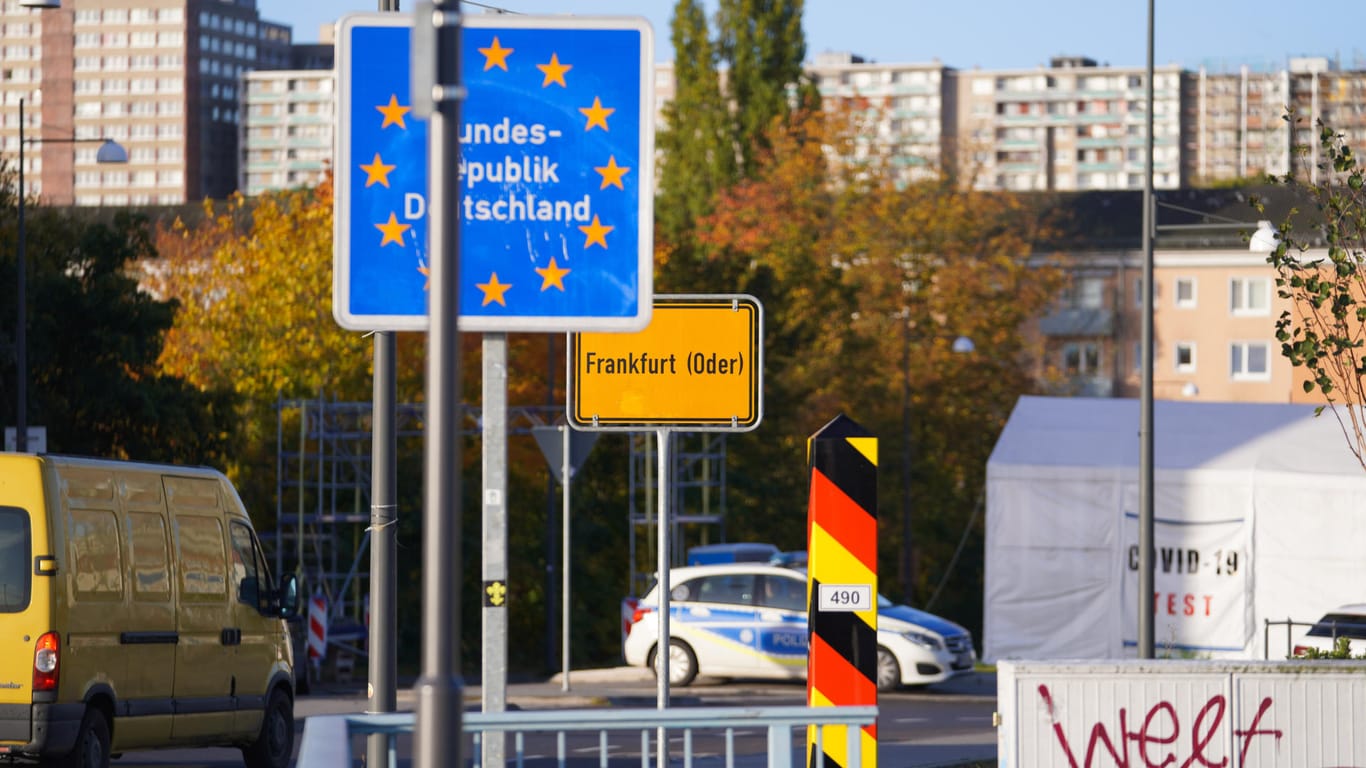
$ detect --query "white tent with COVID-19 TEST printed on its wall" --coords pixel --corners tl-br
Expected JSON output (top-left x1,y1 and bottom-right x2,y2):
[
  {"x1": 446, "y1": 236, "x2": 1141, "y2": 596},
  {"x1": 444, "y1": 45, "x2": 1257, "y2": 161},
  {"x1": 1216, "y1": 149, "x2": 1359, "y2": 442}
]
[{"x1": 982, "y1": 396, "x2": 1366, "y2": 661}]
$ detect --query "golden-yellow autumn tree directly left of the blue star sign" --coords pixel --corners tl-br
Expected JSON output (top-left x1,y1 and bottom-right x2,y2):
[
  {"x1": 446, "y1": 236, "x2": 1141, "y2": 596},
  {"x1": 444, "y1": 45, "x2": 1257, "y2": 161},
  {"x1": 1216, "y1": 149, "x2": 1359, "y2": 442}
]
[{"x1": 145, "y1": 183, "x2": 421, "y2": 511}]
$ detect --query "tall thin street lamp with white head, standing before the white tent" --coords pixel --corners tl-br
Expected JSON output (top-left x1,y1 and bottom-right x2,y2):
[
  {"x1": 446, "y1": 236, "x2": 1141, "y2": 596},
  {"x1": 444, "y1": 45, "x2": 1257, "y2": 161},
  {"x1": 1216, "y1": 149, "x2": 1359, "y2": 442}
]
[{"x1": 1138, "y1": 0, "x2": 1277, "y2": 659}]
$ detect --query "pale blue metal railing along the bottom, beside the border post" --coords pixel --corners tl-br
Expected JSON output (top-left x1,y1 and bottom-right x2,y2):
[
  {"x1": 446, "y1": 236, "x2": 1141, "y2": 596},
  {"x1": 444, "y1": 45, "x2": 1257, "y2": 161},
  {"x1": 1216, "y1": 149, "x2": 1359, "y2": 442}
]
[{"x1": 298, "y1": 707, "x2": 877, "y2": 768}]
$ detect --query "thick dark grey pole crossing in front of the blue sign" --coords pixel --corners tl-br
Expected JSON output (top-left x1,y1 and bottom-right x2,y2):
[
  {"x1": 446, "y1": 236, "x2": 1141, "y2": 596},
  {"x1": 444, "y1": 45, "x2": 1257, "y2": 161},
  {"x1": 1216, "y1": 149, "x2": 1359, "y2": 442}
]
[{"x1": 413, "y1": 0, "x2": 463, "y2": 768}]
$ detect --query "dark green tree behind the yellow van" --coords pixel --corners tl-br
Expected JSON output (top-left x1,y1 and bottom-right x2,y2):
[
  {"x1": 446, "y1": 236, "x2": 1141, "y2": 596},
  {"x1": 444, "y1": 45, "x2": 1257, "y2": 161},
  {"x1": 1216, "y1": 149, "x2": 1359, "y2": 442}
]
[{"x1": 0, "y1": 189, "x2": 232, "y2": 465}]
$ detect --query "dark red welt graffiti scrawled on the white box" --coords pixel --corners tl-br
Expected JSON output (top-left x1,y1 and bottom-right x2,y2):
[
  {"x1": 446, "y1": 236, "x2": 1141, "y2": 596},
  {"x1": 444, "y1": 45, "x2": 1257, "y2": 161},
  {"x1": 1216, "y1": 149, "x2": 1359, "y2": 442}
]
[{"x1": 1038, "y1": 685, "x2": 1281, "y2": 768}]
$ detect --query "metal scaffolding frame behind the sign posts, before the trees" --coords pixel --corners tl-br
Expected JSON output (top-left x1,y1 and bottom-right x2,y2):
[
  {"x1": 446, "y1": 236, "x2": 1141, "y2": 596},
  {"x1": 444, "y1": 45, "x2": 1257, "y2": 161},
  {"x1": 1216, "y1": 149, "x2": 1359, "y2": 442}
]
[{"x1": 270, "y1": 395, "x2": 725, "y2": 657}]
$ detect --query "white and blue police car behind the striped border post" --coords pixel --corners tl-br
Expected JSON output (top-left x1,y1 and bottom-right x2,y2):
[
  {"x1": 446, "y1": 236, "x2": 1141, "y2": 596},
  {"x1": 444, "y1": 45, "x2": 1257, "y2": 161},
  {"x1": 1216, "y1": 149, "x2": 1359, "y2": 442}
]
[{"x1": 626, "y1": 563, "x2": 977, "y2": 690}]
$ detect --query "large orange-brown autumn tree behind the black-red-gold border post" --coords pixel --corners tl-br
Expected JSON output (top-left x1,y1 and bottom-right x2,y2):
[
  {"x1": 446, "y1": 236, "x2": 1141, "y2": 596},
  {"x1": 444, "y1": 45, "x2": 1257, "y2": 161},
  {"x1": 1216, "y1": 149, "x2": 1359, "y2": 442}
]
[{"x1": 698, "y1": 109, "x2": 1056, "y2": 623}]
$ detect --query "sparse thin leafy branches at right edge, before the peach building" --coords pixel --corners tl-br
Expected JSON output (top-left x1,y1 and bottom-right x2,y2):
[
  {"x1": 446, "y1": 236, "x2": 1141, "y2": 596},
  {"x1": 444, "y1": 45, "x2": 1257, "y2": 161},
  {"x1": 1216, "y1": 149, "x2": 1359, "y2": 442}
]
[{"x1": 1253, "y1": 116, "x2": 1366, "y2": 467}]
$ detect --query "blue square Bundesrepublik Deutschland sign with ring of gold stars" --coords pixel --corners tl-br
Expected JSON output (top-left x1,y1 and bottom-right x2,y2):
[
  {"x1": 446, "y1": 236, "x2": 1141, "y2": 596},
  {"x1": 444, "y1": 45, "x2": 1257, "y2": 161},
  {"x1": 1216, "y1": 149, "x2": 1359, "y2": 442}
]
[{"x1": 332, "y1": 14, "x2": 654, "y2": 332}]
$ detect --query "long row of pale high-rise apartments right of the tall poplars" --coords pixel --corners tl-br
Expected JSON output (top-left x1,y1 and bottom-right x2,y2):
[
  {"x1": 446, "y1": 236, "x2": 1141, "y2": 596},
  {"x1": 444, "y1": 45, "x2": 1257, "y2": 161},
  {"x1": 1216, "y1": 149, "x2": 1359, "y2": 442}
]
[{"x1": 775, "y1": 53, "x2": 1366, "y2": 191}]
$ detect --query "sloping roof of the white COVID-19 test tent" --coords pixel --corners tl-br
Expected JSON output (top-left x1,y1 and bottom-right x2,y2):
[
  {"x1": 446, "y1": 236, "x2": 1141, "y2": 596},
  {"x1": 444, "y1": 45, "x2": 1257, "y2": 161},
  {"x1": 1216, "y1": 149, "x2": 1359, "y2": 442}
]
[{"x1": 988, "y1": 396, "x2": 1366, "y2": 478}]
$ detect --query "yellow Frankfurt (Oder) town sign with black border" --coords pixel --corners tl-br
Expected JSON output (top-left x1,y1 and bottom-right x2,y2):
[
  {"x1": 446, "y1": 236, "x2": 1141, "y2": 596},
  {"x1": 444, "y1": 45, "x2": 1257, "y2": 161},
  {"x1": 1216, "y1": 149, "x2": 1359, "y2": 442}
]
[{"x1": 568, "y1": 294, "x2": 764, "y2": 432}]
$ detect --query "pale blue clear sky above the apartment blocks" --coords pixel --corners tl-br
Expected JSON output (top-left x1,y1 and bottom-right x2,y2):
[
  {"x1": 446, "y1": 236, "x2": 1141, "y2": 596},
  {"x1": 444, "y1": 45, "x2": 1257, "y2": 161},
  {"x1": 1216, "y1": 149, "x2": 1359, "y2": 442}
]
[{"x1": 257, "y1": 0, "x2": 1366, "y2": 71}]
